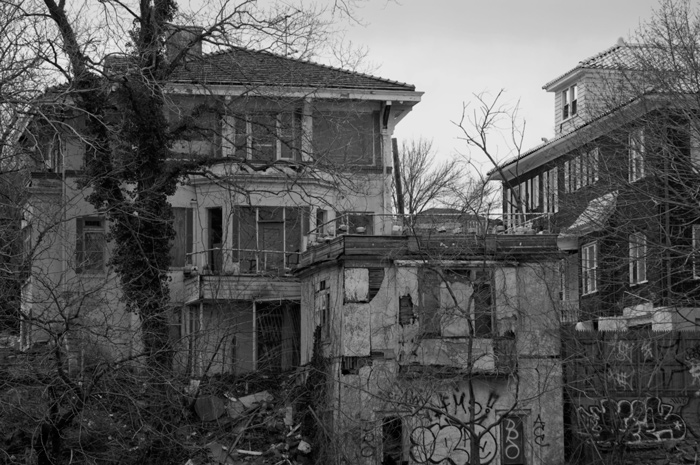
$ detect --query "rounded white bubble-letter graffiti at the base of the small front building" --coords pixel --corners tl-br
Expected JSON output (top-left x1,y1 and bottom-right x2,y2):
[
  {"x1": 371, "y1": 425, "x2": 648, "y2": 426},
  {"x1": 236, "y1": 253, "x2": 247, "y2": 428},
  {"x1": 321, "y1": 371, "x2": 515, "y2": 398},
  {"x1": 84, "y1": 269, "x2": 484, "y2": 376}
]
[{"x1": 411, "y1": 424, "x2": 497, "y2": 465}]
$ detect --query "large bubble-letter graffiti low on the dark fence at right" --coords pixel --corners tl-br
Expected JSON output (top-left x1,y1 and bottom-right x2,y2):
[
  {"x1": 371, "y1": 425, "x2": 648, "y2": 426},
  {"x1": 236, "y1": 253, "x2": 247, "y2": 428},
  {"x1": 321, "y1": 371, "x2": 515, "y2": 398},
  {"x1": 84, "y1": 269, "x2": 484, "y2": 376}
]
[{"x1": 578, "y1": 397, "x2": 687, "y2": 446}]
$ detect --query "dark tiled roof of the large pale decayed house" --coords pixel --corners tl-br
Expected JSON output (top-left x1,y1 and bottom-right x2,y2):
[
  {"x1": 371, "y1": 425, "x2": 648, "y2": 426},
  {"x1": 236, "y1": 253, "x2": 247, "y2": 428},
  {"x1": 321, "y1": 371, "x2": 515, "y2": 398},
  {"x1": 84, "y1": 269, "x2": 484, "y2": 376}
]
[{"x1": 169, "y1": 47, "x2": 416, "y2": 91}]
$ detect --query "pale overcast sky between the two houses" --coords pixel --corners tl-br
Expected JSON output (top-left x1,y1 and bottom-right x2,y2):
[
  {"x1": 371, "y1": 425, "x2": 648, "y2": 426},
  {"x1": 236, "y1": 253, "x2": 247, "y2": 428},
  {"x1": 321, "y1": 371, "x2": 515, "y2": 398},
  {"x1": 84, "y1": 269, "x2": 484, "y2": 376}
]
[{"x1": 346, "y1": 0, "x2": 664, "y2": 171}]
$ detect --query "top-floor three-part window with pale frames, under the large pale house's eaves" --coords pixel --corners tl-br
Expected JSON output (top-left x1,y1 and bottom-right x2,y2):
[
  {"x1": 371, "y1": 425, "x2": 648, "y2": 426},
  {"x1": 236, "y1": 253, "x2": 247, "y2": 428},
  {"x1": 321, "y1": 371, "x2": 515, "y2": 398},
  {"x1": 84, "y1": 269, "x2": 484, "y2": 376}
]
[{"x1": 221, "y1": 112, "x2": 301, "y2": 162}]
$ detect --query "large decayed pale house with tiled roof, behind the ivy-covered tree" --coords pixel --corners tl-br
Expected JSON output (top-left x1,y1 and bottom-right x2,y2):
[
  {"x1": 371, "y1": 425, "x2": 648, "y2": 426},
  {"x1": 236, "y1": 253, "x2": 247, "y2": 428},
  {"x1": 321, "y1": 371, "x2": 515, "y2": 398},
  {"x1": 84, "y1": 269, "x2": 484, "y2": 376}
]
[{"x1": 17, "y1": 36, "x2": 421, "y2": 377}]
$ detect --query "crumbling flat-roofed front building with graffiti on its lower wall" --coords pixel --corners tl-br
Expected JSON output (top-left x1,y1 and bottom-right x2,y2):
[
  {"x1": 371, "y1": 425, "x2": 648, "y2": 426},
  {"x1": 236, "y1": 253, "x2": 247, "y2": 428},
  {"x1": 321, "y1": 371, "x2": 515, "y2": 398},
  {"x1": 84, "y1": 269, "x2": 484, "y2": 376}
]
[{"x1": 299, "y1": 234, "x2": 564, "y2": 465}]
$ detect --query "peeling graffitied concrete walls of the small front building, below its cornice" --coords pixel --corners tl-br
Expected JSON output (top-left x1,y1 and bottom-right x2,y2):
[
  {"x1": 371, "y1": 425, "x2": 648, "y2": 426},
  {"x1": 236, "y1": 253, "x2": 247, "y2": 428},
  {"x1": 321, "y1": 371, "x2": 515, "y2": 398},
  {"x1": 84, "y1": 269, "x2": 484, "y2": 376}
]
[{"x1": 302, "y1": 261, "x2": 564, "y2": 465}]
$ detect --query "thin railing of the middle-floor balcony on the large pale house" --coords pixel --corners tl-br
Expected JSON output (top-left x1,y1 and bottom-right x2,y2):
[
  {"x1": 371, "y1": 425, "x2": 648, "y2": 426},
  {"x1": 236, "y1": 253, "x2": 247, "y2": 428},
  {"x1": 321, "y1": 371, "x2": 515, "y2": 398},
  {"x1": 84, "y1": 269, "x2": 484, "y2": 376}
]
[{"x1": 187, "y1": 247, "x2": 300, "y2": 276}]
